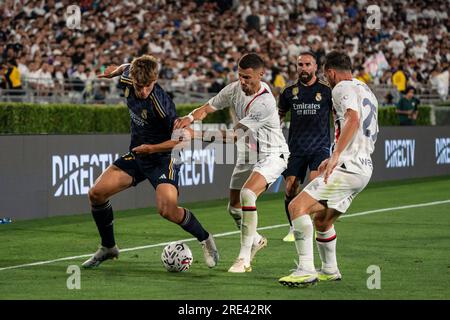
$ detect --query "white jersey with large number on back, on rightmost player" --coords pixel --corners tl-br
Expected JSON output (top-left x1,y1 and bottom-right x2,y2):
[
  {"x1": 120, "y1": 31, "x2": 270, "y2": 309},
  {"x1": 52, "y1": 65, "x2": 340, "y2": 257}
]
[{"x1": 331, "y1": 79, "x2": 378, "y2": 176}]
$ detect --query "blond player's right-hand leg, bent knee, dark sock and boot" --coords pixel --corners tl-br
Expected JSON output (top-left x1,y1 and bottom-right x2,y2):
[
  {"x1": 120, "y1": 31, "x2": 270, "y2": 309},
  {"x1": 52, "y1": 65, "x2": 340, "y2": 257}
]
[{"x1": 156, "y1": 183, "x2": 219, "y2": 268}]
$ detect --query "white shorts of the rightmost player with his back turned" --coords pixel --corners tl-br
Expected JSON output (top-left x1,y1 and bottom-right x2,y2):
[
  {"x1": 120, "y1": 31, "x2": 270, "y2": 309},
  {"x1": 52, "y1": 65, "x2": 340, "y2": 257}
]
[{"x1": 303, "y1": 167, "x2": 370, "y2": 213}]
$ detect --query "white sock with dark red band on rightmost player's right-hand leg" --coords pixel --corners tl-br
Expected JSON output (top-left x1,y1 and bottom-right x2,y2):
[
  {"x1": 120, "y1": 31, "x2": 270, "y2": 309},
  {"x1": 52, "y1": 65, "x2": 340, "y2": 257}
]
[{"x1": 316, "y1": 225, "x2": 338, "y2": 273}]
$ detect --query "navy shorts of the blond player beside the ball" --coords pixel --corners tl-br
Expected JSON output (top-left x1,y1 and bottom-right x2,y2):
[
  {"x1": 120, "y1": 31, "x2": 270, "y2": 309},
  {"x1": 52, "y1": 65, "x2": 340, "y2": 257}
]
[{"x1": 114, "y1": 152, "x2": 180, "y2": 189}]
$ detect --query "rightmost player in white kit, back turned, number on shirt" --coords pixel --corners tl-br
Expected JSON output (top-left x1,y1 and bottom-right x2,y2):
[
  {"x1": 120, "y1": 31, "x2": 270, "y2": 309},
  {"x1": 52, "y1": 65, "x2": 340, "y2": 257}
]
[{"x1": 279, "y1": 51, "x2": 378, "y2": 287}]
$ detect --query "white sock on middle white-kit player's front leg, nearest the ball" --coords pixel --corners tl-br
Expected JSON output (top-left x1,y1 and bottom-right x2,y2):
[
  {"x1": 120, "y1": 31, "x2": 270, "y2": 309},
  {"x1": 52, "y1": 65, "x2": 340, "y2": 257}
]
[{"x1": 239, "y1": 188, "x2": 258, "y2": 265}]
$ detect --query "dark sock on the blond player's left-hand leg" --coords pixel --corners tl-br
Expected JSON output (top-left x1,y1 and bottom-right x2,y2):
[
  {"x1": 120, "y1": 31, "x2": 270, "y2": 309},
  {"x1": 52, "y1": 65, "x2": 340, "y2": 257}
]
[{"x1": 92, "y1": 201, "x2": 116, "y2": 248}]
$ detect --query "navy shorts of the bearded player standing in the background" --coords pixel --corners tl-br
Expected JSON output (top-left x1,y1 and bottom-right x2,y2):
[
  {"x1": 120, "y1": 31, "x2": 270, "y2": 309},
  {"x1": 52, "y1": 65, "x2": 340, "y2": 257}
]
[{"x1": 283, "y1": 151, "x2": 330, "y2": 183}]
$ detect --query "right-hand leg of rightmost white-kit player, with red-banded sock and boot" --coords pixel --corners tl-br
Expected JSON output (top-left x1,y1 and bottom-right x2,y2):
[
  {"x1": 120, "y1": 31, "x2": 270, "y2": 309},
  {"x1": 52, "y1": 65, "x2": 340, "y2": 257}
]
[{"x1": 314, "y1": 208, "x2": 342, "y2": 281}]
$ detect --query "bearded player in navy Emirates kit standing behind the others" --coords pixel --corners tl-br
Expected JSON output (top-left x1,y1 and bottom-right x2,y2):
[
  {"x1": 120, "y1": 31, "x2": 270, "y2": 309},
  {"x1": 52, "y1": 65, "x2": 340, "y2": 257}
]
[{"x1": 278, "y1": 52, "x2": 332, "y2": 242}]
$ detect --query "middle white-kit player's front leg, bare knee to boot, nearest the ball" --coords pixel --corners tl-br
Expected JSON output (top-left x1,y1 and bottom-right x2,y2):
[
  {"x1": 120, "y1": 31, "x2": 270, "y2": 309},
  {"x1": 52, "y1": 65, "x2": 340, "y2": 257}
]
[{"x1": 228, "y1": 171, "x2": 267, "y2": 273}]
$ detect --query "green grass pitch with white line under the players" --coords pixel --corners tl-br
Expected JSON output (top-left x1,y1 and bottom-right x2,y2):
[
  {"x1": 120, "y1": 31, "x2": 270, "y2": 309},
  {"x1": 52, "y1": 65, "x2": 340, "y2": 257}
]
[{"x1": 0, "y1": 176, "x2": 450, "y2": 300}]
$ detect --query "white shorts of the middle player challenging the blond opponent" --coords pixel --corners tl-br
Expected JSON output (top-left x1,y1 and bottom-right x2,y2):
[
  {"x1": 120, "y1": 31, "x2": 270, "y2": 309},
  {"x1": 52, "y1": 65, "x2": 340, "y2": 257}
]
[{"x1": 230, "y1": 154, "x2": 289, "y2": 190}]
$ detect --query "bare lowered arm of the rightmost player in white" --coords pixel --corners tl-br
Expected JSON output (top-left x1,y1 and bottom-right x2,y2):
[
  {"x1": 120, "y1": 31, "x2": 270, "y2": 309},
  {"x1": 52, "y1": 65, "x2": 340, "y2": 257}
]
[{"x1": 323, "y1": 109, "x2": 359, "y2": 183}]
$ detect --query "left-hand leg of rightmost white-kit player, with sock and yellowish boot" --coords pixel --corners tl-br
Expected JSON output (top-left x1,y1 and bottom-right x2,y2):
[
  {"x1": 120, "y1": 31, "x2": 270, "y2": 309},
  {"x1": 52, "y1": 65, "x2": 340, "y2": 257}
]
[{"x1": 279, "y1": 192, "x2": 326, "y2": 286}]
